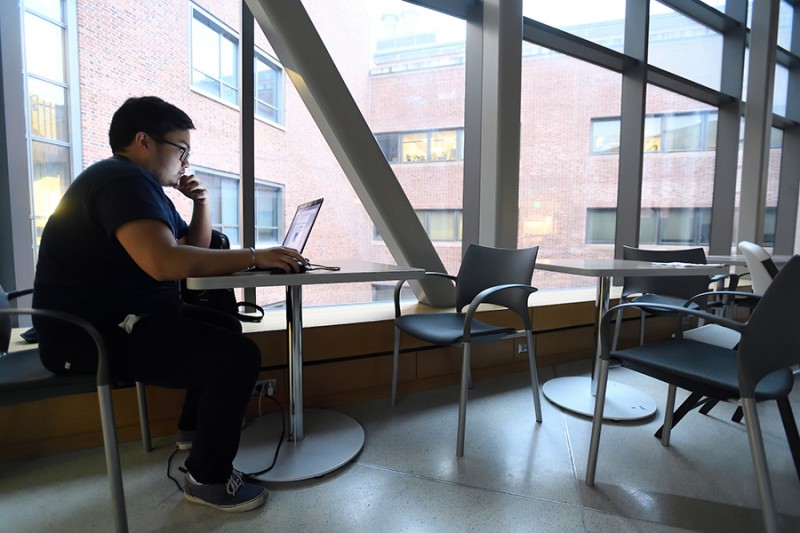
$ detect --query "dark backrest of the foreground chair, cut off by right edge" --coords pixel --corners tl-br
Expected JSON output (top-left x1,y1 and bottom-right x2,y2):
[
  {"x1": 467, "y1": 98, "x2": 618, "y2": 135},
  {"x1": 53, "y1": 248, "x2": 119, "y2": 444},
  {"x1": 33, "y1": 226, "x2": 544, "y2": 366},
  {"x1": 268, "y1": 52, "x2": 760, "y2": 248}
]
[{"x1": 739, "y1": 255, "x2": 800, "y2": 398}]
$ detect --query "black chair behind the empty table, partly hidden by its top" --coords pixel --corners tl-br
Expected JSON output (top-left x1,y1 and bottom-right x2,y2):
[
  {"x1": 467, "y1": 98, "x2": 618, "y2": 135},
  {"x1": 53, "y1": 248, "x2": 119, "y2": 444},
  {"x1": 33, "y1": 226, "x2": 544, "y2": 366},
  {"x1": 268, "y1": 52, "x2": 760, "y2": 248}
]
[{"x1": 612, "y1": 246, "x2": 737, "y2": 347}]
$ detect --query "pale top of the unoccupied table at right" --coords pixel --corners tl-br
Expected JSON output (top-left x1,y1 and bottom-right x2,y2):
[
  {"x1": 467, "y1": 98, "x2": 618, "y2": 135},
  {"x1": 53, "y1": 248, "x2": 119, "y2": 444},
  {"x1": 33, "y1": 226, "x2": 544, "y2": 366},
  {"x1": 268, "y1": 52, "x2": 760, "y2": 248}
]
[{"x1": 536, "y1": 259, "x2": 726, "y2": 277}]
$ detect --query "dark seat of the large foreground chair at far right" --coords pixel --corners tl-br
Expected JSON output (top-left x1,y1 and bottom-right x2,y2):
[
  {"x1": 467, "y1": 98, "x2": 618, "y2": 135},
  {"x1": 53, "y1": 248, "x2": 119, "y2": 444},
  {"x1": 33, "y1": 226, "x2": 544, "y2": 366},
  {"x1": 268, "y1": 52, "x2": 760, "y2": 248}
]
[{"x1": 611, "y1": 338, "x2": 794, "y2": 400}]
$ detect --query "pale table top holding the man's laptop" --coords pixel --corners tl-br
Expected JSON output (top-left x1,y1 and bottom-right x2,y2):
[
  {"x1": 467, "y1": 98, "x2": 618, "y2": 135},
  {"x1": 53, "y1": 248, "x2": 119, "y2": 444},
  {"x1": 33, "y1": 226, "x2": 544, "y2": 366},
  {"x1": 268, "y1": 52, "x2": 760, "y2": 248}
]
[{"x1": 186, "y1": 259, "x2": 425, "y2": 290}]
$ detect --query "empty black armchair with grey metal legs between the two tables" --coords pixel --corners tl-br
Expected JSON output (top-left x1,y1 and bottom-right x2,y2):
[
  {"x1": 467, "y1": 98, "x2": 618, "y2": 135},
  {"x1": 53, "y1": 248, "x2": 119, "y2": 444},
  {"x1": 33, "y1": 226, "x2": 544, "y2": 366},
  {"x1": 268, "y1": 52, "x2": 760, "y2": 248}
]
[{"x1": 392, "y1": 244, "x2": 542, "y2": 457}]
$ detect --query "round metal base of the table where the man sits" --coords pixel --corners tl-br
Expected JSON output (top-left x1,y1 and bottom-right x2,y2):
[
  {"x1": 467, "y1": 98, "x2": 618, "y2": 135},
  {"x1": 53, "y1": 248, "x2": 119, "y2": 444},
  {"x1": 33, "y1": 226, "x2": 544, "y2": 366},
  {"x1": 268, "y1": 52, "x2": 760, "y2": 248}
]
[{"x1": 233, "y1": 409, "x2": 364, "y2": 482}]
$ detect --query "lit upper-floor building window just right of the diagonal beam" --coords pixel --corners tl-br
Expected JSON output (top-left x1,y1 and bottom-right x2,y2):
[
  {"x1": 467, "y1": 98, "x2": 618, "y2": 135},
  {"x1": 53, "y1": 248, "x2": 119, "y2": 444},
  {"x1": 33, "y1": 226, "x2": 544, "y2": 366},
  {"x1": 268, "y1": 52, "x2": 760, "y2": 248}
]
[{"x1": 375, "y1": 128, "x2": 464, "y2": 163}]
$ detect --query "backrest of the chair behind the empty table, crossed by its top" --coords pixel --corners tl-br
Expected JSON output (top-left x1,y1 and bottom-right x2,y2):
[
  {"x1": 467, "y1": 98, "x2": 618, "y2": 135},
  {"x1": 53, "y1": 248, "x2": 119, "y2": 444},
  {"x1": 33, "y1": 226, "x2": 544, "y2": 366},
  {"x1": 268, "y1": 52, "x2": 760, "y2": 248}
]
[{"x1": 622, "y1": 246, "x2": 709, "y2": 300}]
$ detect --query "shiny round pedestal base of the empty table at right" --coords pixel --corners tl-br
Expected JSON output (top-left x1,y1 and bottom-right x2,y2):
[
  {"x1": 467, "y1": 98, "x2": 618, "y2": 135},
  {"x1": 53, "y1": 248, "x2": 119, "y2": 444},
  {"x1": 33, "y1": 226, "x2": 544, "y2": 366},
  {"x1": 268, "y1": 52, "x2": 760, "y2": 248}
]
[{"x1": 542, "y1": 376, "x2": 656, "y2": 420}]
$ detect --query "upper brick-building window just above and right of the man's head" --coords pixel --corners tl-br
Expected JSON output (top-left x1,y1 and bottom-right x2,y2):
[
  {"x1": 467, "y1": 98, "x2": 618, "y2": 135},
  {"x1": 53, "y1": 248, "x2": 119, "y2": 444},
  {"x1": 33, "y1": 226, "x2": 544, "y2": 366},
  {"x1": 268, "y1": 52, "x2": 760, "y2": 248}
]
[{"x1": 192, "y1": 9, "x2": 239, "y2": 105}]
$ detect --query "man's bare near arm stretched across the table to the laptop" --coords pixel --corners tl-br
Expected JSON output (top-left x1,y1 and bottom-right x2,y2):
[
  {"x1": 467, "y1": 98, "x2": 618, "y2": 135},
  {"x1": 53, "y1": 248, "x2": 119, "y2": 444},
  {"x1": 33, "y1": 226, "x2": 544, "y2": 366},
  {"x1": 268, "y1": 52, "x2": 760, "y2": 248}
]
[{"x1": 115, "y1": 218, "x2": 304, "y2": 281}]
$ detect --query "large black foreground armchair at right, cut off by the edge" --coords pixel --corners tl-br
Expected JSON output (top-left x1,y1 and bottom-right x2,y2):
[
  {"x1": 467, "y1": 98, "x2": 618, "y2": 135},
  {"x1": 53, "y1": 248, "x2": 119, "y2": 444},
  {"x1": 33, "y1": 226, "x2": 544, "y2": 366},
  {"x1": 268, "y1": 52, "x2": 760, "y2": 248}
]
[{"x1": 586, "y1": 256, "x2": 800, "y2": 531}]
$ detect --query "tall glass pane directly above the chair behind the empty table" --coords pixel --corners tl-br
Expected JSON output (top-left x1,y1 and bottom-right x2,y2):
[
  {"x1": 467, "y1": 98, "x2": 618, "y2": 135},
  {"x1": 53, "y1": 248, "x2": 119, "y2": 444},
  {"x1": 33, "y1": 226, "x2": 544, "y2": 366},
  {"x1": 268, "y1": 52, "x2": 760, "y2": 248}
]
[{"x1": 639, "y1": 85, "x2": 716, "y2": 245}]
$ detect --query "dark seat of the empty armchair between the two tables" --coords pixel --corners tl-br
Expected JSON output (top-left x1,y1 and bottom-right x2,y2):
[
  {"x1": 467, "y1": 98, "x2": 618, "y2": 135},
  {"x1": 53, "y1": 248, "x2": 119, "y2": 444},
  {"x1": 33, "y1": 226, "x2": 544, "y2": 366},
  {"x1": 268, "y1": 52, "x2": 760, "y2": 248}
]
[{"x1": 395, "y1": 313, "x2": 517, "y2": 346}]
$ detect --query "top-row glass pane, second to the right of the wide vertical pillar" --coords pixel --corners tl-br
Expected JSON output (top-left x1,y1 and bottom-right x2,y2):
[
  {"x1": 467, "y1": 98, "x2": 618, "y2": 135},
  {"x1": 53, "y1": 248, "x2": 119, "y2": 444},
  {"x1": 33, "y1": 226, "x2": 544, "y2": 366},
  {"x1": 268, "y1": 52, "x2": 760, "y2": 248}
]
[{"x1": 647, "y1": 0, "x2": 722, "y2": 89}]
